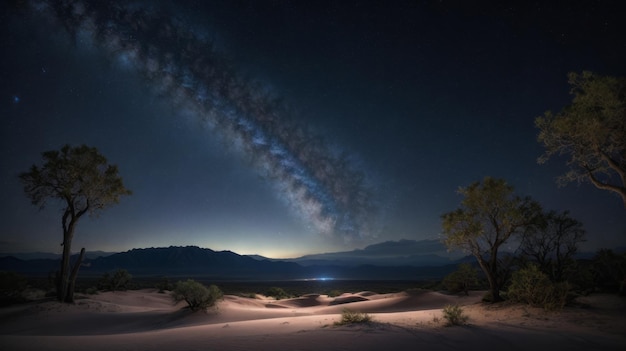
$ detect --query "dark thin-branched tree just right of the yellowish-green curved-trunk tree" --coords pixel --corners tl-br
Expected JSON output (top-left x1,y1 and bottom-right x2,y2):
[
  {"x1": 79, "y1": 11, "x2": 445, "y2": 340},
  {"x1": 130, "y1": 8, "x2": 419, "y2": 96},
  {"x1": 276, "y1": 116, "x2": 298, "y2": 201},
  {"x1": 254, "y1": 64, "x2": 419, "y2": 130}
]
[{"x1": 521, "y1": 211, "x2": 585, "y2": 282}]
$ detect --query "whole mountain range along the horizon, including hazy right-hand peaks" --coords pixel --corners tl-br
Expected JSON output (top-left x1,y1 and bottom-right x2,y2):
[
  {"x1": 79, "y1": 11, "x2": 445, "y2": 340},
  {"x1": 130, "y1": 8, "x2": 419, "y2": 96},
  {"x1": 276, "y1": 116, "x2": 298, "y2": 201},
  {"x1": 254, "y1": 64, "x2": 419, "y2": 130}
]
[{"x1": 0, "y1": 240, "x2": 458, "y2": 280}]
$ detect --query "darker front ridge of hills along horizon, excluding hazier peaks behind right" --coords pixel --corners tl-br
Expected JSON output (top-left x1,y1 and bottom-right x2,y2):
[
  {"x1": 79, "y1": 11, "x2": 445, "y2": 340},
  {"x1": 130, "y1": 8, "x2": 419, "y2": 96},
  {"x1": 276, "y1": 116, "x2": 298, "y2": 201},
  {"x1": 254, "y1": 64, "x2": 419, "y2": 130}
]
[{"x1": 0, "y1": 246, "x2": 456, "y2": 280}]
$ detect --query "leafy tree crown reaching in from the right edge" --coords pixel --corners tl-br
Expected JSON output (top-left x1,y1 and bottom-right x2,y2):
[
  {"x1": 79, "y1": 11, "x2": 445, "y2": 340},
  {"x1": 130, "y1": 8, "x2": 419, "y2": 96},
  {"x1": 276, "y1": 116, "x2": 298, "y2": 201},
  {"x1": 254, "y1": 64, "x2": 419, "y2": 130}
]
[{"x1": 535, "y1": 72, "x2": 626, "y2": 207}]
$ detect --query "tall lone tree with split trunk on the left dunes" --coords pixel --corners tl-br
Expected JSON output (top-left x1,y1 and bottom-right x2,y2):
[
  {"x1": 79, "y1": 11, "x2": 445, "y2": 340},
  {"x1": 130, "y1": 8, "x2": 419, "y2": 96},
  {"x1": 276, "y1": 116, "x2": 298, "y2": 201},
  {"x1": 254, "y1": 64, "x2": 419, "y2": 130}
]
[{"x1": 19, "y1": 145, "x2": 131, "y2": 302}]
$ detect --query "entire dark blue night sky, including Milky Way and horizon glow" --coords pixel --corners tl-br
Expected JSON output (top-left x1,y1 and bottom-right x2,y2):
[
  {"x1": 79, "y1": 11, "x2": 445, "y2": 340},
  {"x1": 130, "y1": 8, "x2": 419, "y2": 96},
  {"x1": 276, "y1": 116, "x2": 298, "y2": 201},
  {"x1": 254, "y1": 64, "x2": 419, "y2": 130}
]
[{"x1": 0, "y1": 0, "x2": 626, "y2": 258}]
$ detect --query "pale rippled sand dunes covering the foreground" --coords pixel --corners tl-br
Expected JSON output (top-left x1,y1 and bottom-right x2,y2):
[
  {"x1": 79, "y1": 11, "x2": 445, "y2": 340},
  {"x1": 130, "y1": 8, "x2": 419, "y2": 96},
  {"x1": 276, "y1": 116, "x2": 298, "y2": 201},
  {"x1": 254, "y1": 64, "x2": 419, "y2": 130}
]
[{"x1": 0, "y1": 290, "x2": 626, "y2": 351}]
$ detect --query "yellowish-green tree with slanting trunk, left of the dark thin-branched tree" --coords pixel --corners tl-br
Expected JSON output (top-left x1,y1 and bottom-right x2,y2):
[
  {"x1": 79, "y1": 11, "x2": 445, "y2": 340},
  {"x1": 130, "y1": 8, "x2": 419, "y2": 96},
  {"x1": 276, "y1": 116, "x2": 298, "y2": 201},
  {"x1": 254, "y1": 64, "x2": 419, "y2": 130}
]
[{"x1": 441, "y1": 177, "x2": 541, "y2": 301}]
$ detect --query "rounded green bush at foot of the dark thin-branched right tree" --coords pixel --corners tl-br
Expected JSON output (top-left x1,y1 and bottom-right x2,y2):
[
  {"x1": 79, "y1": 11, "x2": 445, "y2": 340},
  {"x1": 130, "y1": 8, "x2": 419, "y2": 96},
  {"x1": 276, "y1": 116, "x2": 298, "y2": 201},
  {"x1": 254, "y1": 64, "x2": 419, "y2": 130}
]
[{"x1": 508, "y1": 265, "x2": 569, "y2": 310}]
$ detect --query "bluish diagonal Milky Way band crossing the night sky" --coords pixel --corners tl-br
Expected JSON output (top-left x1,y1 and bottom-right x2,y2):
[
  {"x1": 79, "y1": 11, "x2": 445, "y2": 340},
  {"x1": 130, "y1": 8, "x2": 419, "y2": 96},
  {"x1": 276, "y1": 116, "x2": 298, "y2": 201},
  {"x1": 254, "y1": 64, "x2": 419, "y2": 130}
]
[{"x1": 23, "y1": 1, "x2": 376, "y2": 242}]
